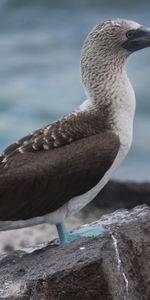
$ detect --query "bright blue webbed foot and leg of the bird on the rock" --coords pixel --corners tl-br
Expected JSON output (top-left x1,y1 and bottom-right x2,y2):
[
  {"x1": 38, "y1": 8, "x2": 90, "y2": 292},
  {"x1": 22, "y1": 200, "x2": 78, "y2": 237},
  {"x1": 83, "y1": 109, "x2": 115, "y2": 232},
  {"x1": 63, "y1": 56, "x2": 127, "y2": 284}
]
[{"x1": 56, "y1": 223, "x2": 105, "y2": 245}]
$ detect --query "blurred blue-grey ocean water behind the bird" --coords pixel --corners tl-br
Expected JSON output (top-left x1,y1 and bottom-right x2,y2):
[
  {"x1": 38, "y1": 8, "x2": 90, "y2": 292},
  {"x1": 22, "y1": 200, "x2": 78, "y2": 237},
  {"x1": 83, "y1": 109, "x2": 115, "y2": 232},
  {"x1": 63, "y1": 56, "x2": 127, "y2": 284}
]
[{"x1": 0, "y1": 0, "x2": 150, "y2": 180}]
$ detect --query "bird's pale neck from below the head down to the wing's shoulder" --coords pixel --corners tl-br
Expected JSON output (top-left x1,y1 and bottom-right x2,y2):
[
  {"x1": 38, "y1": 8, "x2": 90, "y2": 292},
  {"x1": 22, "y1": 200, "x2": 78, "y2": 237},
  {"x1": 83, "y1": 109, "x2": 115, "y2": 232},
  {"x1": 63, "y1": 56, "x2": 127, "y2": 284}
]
[{"x1": 81, "y1": 59, "x2": 135, "y2": 152}]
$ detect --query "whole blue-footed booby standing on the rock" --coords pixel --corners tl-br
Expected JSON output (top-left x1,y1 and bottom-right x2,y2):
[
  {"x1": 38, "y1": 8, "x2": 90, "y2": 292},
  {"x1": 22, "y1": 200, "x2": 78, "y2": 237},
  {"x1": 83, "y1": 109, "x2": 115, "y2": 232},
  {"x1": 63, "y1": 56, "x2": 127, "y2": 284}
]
[{"x1": 0, "y1": 19, "x2": 150, "y2": 245}]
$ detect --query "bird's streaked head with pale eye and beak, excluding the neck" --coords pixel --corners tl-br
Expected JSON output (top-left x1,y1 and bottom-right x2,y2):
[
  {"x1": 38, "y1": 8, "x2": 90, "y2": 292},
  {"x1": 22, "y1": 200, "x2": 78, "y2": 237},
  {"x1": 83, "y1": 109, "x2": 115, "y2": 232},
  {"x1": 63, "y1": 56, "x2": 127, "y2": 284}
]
[{"x1": 82, "y1": 19, "x2": 150, "y2": 57}]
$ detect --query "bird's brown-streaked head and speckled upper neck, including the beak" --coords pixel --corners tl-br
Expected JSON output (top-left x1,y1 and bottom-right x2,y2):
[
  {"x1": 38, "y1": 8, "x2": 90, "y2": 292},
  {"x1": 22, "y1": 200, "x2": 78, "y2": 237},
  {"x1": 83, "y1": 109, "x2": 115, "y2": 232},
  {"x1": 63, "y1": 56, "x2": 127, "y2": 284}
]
[{"x1": 81, "y1": 19, "x2": 150, "y2": 97}]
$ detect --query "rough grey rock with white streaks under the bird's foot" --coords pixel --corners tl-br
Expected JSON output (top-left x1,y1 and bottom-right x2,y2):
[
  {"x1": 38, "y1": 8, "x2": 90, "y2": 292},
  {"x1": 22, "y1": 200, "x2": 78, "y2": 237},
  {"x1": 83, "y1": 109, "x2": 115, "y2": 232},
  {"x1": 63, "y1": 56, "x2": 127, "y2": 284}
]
[{"x1": 0, "y1": 206, "x2": 150, "y2": 300}]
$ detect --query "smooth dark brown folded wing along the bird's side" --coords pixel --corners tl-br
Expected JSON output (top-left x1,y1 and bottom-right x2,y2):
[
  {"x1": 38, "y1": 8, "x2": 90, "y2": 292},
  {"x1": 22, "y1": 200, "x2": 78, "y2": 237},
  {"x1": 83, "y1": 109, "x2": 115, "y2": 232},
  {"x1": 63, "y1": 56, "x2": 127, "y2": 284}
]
[{"x1": 0, "y1": 132, "x2": 120, "y2": 220}]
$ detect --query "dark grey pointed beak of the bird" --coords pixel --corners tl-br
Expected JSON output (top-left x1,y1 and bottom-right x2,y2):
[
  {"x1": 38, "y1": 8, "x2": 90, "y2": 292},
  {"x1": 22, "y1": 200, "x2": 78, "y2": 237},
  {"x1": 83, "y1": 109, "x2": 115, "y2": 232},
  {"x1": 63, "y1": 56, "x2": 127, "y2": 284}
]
[{"x1": 122, "y1": 26, "x2": 150, "y2": 52}]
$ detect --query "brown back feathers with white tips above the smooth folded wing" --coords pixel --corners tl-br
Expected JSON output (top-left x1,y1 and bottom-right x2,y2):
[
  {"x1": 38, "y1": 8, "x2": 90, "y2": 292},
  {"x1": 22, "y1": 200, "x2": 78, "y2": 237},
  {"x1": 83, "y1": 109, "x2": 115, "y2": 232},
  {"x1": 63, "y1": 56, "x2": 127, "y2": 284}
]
[{"x1": 0, "y1": 112, "x2": 109, "y2": 162}]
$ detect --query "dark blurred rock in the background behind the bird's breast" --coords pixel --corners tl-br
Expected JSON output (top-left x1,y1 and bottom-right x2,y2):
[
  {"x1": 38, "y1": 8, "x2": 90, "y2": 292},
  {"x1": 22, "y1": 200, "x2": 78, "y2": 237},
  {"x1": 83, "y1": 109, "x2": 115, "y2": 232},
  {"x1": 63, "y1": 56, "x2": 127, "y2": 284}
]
[{"x1": 88, "y1": 180, "x2": 150, "y2": 210}]
